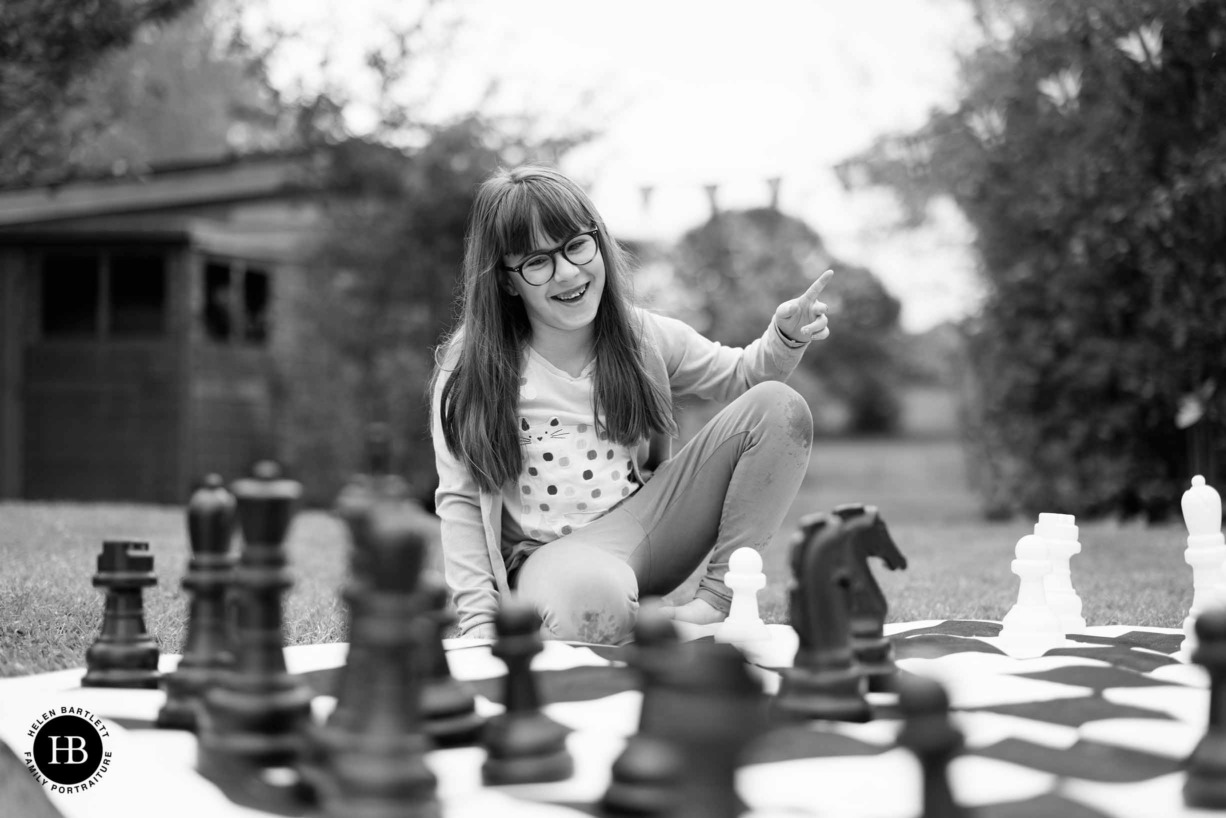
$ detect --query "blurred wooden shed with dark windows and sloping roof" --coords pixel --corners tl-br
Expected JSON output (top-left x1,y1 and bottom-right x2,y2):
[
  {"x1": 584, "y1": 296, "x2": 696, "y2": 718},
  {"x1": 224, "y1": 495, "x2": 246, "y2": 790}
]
[{"x1": 0, "y1": 155, "x2": 321, "y2": 503}]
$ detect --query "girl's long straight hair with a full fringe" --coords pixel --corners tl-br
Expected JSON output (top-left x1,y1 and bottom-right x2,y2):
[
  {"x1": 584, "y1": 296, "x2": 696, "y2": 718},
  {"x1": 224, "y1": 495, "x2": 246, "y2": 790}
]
[{"x1": 430, "y1": 166, "x2": 677, "y2": 492}]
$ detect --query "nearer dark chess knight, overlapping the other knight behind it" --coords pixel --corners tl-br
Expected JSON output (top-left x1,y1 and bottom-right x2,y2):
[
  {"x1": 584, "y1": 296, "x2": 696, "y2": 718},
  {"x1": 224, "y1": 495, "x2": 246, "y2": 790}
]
[{"x1": 775, "y1": 514, "x2": 872, "y2": 721}]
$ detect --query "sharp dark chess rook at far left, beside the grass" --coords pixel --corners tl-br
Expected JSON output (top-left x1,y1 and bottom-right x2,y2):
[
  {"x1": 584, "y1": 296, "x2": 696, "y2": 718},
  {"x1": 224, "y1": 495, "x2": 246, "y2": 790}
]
[{"x1": 81, "y1": 540, "x2": 159, "y2": 688}]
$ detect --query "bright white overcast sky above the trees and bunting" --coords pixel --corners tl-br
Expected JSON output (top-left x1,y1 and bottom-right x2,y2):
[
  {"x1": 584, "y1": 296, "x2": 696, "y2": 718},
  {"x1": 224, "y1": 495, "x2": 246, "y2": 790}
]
[{"x1": 253, "y1": 0, "x2": 981, "y2": 331}]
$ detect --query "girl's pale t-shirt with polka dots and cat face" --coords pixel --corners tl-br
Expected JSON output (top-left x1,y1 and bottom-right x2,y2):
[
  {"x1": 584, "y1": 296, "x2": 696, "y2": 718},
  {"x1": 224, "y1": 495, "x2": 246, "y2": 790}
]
[{"x1": 503, "y1": 347, "x2": 639, "y2": 548}]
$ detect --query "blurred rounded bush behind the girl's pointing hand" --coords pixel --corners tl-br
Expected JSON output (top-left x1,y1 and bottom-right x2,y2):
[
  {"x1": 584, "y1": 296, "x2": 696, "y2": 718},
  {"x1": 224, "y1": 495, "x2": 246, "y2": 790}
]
[{"x1": 677, "y1": 208, "x2": 900, "y2": 434}]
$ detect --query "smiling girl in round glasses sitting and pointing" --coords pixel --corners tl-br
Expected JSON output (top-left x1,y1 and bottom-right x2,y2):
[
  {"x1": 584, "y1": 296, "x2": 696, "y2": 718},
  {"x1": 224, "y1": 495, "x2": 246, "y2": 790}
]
[{"x1": 430, "y1": 166, "x2": 831, "y2": 643}]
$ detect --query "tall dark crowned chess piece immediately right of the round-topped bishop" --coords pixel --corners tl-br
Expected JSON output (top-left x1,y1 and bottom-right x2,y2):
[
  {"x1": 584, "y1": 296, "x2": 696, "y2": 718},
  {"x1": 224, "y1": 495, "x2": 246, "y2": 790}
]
[{"x1": 196, "y1": 461, "x2": 314, "y2": 809}]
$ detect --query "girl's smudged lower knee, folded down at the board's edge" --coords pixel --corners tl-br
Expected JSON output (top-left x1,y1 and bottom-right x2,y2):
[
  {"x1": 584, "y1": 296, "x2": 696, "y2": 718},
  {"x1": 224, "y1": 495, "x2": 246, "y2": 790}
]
[{"x1": 520, "y1": 546, "x2": 639, "y2": 644}]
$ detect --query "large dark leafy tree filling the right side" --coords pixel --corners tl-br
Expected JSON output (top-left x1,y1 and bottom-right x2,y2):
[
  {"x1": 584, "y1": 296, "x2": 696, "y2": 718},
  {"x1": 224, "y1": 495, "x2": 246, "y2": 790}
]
[{"x1": 845, "y1": 0, "x2": 1226, "y2": 519}]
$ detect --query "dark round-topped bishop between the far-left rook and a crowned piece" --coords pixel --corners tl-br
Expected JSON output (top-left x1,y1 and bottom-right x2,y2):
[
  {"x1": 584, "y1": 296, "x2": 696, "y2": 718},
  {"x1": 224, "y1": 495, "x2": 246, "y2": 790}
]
[{"x1": 157, "y1": 475, "x2": 235, "y2": 731}]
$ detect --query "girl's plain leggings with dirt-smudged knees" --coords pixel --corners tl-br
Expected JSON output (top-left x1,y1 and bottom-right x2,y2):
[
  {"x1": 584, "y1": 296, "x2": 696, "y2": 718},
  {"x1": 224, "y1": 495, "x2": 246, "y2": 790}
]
[{"x1": 511, "y1": 381, "x2": 813, "y2": 644}]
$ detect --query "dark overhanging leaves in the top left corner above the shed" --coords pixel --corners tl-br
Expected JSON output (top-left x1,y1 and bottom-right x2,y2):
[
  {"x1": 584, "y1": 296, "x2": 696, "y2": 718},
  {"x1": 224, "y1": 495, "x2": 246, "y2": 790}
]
[{"x1": 0, "y1": 0, "x2": 195, "y2": 184}]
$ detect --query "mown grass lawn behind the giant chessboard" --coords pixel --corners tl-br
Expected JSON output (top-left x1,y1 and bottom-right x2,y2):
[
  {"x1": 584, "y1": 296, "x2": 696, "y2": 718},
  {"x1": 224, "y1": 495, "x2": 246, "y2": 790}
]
[{"x1": 0, "y1": 439, "x2": 1192, "y2": 676}]
